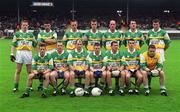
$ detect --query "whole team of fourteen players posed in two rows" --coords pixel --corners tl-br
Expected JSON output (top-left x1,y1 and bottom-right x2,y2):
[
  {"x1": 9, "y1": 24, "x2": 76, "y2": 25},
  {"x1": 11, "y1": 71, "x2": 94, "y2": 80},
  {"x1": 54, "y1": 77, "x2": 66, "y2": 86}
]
[{"x1": 10, "y1": 19, "x2": 171, "y2": 98}]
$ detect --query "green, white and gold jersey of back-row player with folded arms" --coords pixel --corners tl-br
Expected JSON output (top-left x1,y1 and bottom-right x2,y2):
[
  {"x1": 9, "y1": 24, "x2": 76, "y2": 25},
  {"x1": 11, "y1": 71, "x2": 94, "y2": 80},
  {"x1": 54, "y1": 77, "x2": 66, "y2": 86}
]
[{"x1": 37, "y1": 30, "x2": 57, "y2": 50}]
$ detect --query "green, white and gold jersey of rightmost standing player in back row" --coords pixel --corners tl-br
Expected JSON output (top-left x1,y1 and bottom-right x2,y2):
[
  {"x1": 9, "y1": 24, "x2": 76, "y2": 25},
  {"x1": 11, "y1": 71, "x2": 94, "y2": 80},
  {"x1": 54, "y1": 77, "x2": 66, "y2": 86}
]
[{"x1": 146, "y1": 29, "x2": 170, "y2": 49}]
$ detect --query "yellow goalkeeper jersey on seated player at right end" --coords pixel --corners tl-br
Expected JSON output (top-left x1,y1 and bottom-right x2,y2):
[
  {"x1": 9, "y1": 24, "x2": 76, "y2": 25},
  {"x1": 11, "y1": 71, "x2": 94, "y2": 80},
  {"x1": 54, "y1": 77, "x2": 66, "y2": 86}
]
[{"x1": 140, "y1": 51, "x2": 163, "y2": 70}]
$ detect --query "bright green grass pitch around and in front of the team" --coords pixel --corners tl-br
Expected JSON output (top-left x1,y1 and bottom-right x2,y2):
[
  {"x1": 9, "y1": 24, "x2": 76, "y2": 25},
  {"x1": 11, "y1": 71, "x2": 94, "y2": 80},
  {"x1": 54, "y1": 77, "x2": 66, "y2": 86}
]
[{"x1": 0, "y1": 39, "x2": 180, "y2": 112}]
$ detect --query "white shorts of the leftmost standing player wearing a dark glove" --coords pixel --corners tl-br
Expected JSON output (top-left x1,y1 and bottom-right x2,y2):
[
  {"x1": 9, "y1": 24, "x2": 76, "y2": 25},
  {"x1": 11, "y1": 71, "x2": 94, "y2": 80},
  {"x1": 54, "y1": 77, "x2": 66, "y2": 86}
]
[{"x1": 16, "y1": 50, "x2": 32, "y2": 64}]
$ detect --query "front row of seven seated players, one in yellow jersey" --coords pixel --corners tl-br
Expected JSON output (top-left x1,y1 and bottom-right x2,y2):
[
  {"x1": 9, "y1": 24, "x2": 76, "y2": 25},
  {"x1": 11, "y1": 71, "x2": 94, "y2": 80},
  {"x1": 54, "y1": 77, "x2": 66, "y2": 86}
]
[{"x1": 22, "y1": 39, "x2": 168, "y2": 98}]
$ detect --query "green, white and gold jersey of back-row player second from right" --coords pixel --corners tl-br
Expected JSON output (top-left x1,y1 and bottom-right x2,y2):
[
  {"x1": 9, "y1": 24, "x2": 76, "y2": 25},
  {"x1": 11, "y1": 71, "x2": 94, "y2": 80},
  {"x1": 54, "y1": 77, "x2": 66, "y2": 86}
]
[{"x1": 124, "y1": 30, "x2": 144, "y2": 50}]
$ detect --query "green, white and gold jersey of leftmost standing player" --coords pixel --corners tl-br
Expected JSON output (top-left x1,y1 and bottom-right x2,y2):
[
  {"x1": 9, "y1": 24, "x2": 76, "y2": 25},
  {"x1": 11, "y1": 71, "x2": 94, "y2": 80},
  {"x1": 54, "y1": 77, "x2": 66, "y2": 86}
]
[{"x1": 12, "y1": 30, "x2": 37, "y2": 51}]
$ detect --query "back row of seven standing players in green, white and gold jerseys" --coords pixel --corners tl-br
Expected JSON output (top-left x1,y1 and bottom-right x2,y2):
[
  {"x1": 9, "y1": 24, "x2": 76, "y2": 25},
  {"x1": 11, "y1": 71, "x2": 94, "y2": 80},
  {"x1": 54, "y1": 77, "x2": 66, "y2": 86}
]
[{"x1": 11, "y1": 19, "x2": 170, "y2": 97}]
